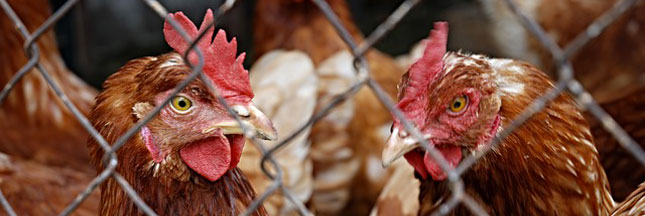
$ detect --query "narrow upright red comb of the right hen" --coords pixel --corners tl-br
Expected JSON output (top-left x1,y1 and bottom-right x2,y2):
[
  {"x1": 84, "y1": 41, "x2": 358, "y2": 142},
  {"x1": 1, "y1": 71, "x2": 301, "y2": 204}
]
[{"x1": 395, "y1": 22, "x2": 448, "y2": 126}]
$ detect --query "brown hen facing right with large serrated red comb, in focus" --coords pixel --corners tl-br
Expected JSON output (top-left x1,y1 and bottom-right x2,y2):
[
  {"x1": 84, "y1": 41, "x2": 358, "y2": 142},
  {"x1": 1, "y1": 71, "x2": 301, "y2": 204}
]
[{"x1": 88, "y1": 10, "x2": 276, "y2": 215}]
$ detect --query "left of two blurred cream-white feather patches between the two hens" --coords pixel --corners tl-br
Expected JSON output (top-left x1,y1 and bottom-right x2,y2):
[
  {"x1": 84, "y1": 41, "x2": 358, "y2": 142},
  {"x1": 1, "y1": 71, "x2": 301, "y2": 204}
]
[{"x1": 238, "y1": 50, "x2": 318, "y2": 215}]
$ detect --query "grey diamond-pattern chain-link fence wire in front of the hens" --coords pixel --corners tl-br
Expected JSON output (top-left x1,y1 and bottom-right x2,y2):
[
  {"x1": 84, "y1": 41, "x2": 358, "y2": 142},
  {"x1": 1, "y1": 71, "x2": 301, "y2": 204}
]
[{"x1": 0, "y1": 0, "x2": 645, "y2": 216}]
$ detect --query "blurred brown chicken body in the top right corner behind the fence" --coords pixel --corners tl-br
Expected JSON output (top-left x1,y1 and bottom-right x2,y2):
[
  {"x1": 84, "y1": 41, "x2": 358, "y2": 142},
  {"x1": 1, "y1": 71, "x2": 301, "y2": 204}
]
[{"x1": 482, "y1": 0, "x2": 645, "y2": 102}]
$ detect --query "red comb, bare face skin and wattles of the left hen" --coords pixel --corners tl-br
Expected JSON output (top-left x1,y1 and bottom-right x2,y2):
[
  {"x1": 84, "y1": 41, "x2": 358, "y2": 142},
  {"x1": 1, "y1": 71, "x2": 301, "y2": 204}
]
[{"x1": 147, "y1": 9, "x2": 253, "y2": 181}]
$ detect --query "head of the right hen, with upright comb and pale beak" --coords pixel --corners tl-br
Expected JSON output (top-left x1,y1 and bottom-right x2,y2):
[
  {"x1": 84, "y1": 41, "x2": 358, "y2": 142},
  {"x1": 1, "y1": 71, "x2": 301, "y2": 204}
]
[{"x1": 383, "y1": 22, "x2": 523, "y2": 180}]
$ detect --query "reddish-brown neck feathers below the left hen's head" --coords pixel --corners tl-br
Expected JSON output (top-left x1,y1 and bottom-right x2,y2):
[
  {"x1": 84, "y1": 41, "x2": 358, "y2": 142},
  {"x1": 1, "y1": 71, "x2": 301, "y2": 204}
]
[{"x1": 100, "y1": 168, "x2": 266, "y2": 215}]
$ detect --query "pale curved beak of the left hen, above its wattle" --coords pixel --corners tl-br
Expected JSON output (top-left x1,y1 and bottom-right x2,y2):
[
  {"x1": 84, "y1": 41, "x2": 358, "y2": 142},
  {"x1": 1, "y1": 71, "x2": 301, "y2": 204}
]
[{"x1": 202, "y1": 103, "x2": 278, "y2": 140}]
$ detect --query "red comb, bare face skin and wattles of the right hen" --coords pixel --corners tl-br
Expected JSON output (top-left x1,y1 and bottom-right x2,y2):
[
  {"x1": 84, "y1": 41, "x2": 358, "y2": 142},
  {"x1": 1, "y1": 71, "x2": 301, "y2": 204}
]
[{"x1": 393, "y1": 22, "x2": 498, "y2": 181}]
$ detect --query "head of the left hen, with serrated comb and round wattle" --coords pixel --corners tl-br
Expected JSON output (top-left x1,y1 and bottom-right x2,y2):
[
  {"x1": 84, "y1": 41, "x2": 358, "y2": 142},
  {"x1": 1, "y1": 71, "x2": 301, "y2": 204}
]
[{"x1": 91, "y1": 10, "x2": 276, "y2": 181}]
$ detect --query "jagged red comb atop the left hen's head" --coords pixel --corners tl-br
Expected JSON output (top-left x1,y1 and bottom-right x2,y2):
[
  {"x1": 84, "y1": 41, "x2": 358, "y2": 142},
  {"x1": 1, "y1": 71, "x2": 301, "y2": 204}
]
[{"x1": 163, "y1": 9, "x2": 253, "y2": 103}]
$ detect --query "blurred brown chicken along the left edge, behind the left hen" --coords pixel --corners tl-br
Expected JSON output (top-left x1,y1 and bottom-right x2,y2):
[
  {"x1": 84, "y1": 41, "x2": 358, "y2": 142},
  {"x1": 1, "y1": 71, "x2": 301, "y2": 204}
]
[{"x1": 0, "y1": 0, "x2": 99, "y2": 215}]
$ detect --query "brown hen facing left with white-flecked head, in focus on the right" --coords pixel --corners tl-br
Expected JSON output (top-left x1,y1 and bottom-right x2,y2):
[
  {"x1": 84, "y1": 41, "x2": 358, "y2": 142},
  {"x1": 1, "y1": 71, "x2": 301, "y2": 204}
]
[{"x1": 383, "y1": 23, "x2": 640, "y2": 215}]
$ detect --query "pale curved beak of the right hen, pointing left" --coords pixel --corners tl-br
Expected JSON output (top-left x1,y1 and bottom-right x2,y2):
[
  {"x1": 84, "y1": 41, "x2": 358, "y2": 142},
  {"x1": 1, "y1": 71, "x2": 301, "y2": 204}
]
[{"x1": 382, "y1": 127, "x2": 421, "y2": 167}]
